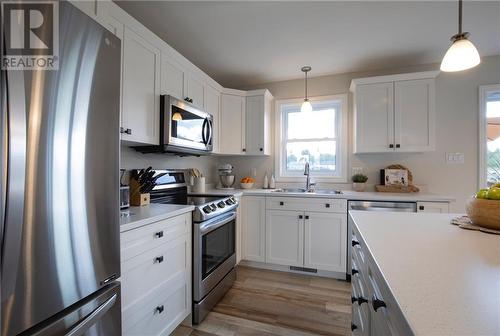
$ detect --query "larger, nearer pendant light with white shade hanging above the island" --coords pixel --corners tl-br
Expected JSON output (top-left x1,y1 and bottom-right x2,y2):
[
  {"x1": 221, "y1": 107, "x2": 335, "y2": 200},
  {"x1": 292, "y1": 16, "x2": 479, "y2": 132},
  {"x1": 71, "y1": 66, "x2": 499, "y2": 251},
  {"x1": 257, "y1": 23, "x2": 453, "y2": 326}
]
[{"x1": 441, "y1": 0, "x2": 481, "y2": 72}]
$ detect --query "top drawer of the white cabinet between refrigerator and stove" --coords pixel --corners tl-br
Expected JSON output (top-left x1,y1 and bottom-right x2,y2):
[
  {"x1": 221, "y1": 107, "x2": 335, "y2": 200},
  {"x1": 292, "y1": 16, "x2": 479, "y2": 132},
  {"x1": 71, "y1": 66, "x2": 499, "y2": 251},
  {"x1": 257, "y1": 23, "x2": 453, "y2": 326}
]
[{"x1": 120, "y1": 213, "x2": 191, "y2": 263}]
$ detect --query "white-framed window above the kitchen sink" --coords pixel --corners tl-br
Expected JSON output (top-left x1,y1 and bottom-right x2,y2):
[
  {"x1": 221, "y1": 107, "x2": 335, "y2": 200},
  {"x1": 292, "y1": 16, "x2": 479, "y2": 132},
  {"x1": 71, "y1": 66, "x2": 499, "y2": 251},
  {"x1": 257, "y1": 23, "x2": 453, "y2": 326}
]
[{"x1": 276, "y1": 95, "x2": 347, "y2": 182}]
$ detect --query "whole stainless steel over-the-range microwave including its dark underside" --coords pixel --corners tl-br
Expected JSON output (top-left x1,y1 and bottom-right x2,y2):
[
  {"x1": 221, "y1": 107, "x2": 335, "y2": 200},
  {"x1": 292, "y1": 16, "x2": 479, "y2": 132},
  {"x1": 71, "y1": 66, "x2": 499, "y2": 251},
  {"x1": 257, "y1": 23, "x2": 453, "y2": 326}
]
[{"x1": 135, "y1": 95, "x2": 213, "y2": 155}]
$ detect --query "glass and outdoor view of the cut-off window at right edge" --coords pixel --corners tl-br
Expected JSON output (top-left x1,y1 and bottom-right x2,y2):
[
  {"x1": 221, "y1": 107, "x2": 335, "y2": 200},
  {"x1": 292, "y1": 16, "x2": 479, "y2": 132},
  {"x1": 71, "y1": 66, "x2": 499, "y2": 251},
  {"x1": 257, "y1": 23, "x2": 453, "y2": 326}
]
[{"x1": 486, "y1": 92, "x2": 500, "y2": 185}]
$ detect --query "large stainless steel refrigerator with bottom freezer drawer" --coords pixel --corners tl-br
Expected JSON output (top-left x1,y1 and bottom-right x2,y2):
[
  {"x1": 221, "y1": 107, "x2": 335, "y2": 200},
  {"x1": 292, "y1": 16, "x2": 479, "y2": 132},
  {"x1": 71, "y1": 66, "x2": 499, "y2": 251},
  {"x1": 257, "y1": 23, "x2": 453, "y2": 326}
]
[{"x1": 0, "y1": 1, "x2": 121, "y2": 336}]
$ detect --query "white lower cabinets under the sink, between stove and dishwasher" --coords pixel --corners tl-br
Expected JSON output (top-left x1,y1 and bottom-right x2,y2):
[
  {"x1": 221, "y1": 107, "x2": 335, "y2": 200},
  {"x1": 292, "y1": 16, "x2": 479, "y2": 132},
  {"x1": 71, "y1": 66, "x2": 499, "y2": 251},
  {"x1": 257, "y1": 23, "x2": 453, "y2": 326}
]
[{"x1": 241, "y1": 196, "x2": 347, "y2": 276}]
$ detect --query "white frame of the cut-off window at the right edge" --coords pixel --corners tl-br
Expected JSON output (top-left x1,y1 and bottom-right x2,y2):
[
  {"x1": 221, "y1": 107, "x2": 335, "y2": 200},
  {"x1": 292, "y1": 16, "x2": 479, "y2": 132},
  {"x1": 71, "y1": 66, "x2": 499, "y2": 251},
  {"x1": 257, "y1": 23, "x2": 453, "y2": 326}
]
[{"x1": 478, "y1": 84, "x2": 500, "y2": 189}]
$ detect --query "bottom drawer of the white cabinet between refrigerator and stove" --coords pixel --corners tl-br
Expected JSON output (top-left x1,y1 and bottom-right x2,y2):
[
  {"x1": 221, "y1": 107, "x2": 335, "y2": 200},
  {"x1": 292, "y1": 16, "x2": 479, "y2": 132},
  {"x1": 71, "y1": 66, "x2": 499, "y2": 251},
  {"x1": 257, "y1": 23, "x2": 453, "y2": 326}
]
[{"x1": 122, "y1": 272, "x2": 191, "y2": 336}]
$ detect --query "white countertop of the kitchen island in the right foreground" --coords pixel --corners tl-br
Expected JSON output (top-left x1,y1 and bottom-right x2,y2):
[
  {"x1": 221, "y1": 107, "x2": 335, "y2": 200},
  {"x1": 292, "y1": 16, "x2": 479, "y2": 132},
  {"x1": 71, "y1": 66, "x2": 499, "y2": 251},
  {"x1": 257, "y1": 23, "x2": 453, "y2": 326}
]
[{"x1": 351, "y1": 211, "x2": 500, "y2": 336}]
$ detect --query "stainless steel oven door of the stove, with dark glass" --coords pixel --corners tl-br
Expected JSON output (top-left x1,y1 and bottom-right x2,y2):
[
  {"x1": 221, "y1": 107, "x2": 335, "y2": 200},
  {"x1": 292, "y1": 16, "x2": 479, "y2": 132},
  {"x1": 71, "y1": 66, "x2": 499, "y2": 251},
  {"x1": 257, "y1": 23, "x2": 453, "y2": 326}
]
[{"x1": 193, "y1": 212, "x2": 236, "y2": 302}]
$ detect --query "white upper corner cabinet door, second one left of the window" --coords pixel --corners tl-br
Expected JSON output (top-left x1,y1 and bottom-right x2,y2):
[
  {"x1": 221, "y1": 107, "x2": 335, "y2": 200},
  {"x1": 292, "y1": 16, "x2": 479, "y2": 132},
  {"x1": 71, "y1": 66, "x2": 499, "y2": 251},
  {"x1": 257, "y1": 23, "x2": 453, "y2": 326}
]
[{"x1": 219, "y1": 94, "x2": 245, "y2": 154}]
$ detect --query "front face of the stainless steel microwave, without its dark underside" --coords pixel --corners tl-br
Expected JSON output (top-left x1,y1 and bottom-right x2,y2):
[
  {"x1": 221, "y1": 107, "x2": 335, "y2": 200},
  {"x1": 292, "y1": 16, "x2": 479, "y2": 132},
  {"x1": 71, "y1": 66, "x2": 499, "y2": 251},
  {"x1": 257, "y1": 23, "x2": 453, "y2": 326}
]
[{"x1": 161, "y1": 95, "x2": 213, "y2": 151}]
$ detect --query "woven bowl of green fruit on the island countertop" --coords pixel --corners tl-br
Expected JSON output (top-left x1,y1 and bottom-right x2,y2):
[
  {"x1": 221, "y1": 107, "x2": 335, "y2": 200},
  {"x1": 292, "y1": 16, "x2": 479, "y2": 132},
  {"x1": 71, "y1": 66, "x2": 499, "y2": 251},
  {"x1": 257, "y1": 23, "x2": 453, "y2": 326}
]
[{"x1": 466, "y1": 183, "x2": 500, "y2": 230}]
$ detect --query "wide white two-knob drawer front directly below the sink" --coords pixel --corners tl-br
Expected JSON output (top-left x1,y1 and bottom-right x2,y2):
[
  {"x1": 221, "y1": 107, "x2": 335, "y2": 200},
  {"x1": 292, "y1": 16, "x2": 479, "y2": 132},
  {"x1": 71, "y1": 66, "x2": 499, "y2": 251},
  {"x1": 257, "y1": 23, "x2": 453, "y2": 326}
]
[{"x1": 266, "y1": 197, "x2": 347, "y2": 213}]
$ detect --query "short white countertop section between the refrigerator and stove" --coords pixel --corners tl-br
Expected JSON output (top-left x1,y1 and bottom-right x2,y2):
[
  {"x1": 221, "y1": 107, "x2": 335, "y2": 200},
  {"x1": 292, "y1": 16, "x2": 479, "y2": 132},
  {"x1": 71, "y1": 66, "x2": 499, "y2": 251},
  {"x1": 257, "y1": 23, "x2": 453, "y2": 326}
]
[{"x1": 120, "y1": 203, "x2": 194, "y2": 232}]
